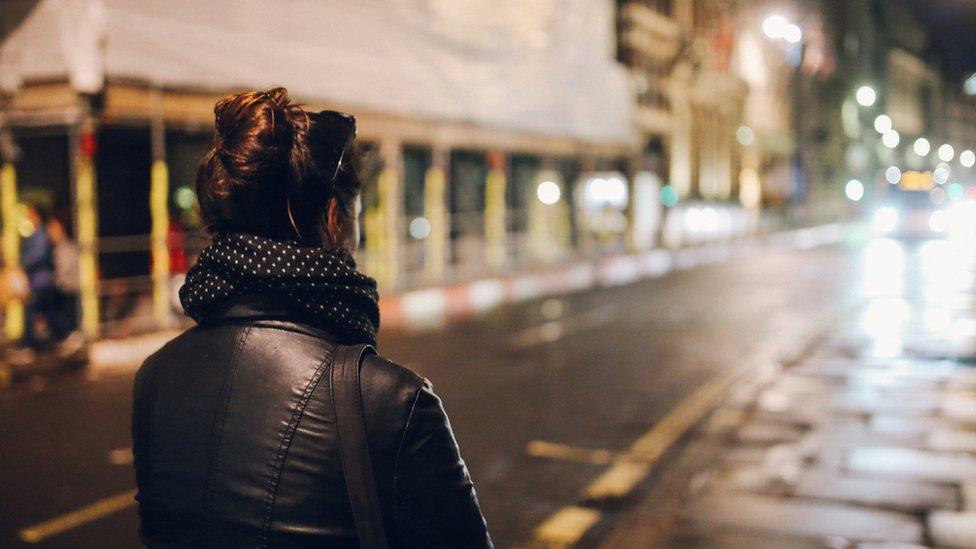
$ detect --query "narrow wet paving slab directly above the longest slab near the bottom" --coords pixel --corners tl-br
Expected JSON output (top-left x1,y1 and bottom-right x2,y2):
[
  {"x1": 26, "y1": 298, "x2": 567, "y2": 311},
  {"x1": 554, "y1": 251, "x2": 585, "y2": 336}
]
[{"x1": 792, "y1": 470, "x2": 958, "y2": 512}]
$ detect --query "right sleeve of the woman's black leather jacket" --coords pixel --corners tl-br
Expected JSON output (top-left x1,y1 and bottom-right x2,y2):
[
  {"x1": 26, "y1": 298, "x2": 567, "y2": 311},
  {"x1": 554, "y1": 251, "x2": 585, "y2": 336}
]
[{"x1": 396, "y1": 380, "x2": 492, "y2": 548}]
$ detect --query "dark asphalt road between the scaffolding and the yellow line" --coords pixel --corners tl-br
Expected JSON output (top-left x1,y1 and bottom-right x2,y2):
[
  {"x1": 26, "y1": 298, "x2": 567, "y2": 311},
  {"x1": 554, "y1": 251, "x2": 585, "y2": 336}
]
[{"x1": 0, "y1": 242, "x2": 862, "y2": 547}]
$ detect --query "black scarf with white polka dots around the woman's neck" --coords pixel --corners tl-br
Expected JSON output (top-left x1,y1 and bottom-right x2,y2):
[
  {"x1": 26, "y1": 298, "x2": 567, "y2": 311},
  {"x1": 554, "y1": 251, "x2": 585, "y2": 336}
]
[{"x1": 180, "y1": 234, "x2": 380, "y2": 344}]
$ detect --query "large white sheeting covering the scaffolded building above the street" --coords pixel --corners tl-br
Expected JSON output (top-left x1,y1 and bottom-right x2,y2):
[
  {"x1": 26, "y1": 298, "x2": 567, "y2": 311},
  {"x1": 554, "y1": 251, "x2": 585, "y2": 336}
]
[{"x1": 0, "y1": 0, "x2": 633, "y2": 142}]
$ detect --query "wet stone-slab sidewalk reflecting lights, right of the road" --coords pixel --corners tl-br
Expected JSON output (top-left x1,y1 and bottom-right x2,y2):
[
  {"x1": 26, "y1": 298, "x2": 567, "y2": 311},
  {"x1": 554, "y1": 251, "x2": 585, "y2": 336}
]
[{"x1": 602, "y1": 256, "x2": 976, "y2": 547}]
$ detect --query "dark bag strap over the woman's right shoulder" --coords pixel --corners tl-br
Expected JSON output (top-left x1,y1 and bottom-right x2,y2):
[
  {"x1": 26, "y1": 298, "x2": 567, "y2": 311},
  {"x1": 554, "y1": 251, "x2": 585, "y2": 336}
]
[{"x1": 331, "y1": 345, "x2": 387, "y2": 549}]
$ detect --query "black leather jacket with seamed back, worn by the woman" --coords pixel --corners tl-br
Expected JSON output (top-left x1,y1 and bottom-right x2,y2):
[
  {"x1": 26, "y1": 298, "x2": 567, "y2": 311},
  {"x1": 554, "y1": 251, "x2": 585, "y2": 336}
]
[{"x1": 132, "y1": 299, "x2": 491, "y2": 547}]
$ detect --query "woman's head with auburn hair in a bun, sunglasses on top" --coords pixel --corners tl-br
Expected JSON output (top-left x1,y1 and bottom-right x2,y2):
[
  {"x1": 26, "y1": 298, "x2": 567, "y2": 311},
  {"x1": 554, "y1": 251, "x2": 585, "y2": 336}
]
[{"x1": 197, "y1": 88, "x2": 361, "y2": 251}]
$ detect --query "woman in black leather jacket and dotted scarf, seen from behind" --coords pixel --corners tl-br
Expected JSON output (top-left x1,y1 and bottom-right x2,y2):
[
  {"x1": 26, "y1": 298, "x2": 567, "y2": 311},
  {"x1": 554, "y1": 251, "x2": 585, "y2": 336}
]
[{"x1": 132, "y1": 88, "x2": 491, "y2": 547}]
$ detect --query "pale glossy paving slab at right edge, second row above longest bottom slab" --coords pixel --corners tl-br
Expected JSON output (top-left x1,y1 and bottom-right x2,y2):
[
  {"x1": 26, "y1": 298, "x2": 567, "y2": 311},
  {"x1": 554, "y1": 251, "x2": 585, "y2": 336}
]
[{"x1": 847, "y1": 446, "x2": 976, "y2": 483}]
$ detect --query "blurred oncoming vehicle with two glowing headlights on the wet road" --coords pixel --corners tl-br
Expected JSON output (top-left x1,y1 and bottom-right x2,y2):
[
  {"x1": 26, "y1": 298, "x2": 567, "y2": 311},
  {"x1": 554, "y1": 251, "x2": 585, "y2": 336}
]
[{"x1": 872, "y1": 187, "x2": 949, "y2": 239}]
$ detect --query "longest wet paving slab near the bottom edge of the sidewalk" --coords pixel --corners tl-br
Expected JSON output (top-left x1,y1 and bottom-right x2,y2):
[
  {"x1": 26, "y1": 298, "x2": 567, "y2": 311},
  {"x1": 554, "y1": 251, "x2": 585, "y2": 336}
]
[{"x1": 690, "y1": 492, "x2": 922, "y2": 543}]
